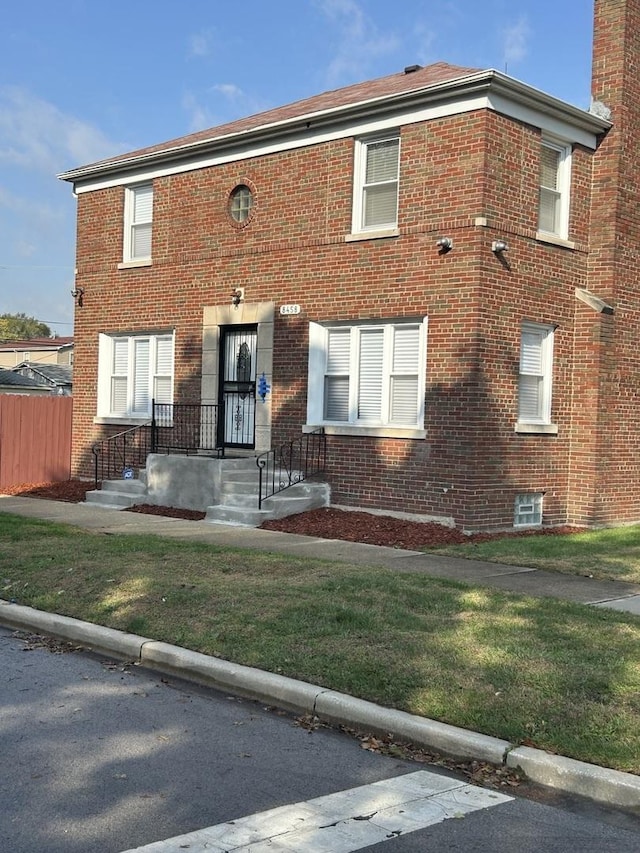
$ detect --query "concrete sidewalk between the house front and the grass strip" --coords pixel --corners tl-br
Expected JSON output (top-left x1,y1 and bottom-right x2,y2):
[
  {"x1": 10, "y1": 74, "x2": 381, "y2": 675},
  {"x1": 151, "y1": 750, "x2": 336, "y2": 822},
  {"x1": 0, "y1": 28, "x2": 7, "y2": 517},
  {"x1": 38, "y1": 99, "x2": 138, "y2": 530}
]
[{"x1": 0, "y1": 495, "x2": 640, "y2": 615}]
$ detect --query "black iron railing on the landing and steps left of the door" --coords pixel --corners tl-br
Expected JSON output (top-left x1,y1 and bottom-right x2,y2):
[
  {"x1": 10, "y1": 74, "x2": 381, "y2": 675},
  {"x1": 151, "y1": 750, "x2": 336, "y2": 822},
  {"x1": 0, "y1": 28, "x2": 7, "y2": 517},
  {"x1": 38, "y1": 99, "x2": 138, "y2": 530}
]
[{"x1": 92, "y1": 401, "x2": 224, "y2": 488}]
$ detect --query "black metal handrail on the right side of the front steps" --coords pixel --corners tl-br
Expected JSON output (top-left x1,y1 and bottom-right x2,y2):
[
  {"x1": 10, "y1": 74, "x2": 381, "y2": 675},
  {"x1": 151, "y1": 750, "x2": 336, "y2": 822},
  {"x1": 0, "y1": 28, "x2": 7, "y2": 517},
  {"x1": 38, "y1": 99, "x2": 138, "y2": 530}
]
[{"x1": 256, "y1": 427, "x2": 327, "y2": 509}]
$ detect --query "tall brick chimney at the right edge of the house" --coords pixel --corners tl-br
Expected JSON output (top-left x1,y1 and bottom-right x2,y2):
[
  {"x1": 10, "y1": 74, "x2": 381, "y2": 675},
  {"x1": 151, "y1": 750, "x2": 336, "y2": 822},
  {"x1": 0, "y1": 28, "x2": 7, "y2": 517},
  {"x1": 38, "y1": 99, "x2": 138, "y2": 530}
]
[{"x1": 568, "y1": 0, "x2": 640, "y2": 524}]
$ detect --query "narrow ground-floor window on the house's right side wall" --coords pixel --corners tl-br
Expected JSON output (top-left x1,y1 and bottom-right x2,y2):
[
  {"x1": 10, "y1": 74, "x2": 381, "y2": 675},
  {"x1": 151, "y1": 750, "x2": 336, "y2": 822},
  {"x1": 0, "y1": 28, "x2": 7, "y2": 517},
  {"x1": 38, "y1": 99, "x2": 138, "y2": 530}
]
[{"x1": 518, "y1": 323, "x2": 553, "y2": 424}]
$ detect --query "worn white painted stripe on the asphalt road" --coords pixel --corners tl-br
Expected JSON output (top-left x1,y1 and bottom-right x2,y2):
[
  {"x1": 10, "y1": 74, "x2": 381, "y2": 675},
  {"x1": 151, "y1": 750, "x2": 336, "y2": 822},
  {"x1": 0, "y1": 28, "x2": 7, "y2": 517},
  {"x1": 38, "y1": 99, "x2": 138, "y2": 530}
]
[{"x1": 119, "y1": 770, "x2": 513, "y2": 853}]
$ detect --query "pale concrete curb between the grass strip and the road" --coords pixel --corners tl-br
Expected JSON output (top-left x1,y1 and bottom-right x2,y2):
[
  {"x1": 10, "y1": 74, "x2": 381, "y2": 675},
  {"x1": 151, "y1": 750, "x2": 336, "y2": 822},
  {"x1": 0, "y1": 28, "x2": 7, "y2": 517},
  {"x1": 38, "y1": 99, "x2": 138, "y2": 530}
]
[{"x1": 0, "y1": 599, "x2": 640, "y2": 808}]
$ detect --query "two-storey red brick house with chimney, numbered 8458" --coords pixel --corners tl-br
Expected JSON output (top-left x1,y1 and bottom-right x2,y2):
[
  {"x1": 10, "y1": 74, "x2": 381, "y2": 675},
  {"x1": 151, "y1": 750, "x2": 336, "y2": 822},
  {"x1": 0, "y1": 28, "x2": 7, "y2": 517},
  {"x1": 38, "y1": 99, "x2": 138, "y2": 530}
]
[{"x1": 61, "y1": 0, "x2": 640, "y2": 530}]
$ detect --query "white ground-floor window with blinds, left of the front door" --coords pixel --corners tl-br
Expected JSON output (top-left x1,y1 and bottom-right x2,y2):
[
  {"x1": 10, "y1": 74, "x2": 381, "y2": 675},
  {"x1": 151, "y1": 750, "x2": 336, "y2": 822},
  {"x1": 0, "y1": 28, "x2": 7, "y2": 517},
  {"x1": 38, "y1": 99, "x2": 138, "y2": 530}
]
[{"x1": 98, "y1": 334, "x2": 173, "y2": 418}]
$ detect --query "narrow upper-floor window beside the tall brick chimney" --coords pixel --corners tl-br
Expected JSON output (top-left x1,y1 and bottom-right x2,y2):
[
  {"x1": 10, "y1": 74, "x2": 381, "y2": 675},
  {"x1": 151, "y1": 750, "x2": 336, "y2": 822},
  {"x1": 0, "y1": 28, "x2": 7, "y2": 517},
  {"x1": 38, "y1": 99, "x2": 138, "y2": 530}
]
[{"x1": 538, "y1": 141, "x2": 571, "y2": 239}]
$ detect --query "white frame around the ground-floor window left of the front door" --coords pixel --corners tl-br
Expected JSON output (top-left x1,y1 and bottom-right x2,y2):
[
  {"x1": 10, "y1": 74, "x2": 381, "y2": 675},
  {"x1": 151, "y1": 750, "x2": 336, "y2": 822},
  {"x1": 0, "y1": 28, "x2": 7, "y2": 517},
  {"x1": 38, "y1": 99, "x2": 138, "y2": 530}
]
[{"x1": 95, "y1": 332, "x2": 175, "y2": 424}]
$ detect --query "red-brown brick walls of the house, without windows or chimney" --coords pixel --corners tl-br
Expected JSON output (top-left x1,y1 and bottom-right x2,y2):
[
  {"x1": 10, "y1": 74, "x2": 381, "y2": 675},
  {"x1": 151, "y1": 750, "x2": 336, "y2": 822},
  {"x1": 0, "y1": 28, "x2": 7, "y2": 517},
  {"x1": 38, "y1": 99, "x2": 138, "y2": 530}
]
[{"x1": 74, "y1": 103, "x2": 591, "y2": 528}]
